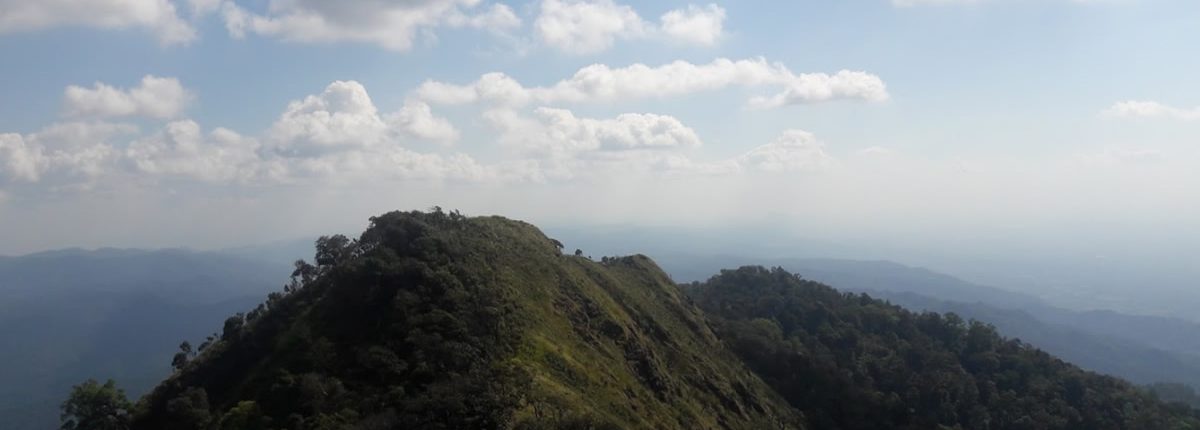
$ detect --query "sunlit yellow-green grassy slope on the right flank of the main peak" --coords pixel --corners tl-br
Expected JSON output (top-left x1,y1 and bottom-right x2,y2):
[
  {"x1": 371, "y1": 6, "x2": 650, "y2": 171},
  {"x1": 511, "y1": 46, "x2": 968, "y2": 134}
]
[{"x1": 439, "y1": 217, "x2": 791, "y2": 429}]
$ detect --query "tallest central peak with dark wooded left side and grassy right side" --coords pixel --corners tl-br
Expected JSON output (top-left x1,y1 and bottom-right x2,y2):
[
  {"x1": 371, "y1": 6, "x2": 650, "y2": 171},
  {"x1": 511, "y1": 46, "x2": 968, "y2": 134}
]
[{"x1": 132, "y1": 210, "x2": 800, "y2": 430}]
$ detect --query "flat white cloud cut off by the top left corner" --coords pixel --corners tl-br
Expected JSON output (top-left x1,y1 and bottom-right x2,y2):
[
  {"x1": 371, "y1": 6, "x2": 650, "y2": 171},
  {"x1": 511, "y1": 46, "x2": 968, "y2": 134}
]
[{"x1": 0, "y1": 0, "x2": 196, "y2": 44}]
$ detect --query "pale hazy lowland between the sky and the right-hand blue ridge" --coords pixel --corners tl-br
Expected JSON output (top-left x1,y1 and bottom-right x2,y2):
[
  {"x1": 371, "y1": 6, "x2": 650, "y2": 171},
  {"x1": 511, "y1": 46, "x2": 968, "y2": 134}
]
[{"x1": 550, "y1": 224, "x2": 1200, "y2": 321}]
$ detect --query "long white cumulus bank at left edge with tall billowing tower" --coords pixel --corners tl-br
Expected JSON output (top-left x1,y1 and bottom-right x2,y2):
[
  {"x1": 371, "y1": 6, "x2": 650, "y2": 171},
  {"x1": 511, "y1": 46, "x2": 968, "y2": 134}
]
[{"x1": 0, "y1": 80, "x2": 496, "y2": 190}]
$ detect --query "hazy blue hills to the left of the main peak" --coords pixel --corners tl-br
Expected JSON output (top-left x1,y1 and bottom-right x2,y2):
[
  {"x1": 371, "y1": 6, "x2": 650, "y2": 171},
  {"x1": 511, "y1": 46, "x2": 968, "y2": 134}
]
[{"x1": 0, "y1": 249, "x2": 289, "y2": 430}]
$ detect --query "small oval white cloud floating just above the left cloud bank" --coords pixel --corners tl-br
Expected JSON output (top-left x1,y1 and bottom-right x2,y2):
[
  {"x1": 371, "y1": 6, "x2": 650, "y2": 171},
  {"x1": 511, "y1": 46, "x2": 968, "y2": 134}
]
[{"x1": 62, "y1": 74, "x2": 194, "y2": 118}]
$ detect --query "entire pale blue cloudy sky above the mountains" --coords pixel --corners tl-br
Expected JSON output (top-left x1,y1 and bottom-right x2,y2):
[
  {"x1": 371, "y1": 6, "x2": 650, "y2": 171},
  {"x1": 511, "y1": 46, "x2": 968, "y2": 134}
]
[{"x1": 0, "y1": 0, "x2": 1200, "y2": 269}]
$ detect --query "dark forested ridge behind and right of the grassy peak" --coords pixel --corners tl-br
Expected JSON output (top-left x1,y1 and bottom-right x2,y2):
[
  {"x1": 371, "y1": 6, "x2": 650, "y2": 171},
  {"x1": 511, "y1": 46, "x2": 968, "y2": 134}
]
[{"x1": 689, "y1": 267, "x2": 1200, "y2": 429}]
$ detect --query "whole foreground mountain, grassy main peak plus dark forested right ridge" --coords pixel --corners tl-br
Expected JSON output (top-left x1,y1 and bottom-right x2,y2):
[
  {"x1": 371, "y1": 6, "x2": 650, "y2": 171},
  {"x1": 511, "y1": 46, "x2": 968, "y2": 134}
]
[{"x1": 132, "y1": 209, "x2": 1200, "y2": 430}]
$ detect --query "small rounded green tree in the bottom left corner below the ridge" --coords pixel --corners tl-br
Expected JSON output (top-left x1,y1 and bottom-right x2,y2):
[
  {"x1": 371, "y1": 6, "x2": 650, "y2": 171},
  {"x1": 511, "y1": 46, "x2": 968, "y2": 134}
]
[{"x1": 60, "y1": 380, "x2": 133, "y2": 430}]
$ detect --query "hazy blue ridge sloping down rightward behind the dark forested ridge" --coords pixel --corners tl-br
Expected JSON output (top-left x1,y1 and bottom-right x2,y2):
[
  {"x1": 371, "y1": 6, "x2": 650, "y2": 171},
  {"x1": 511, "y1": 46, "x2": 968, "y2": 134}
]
[{"x1": 661, "y1": 256, "x2": 1200, "y2": 387}]
